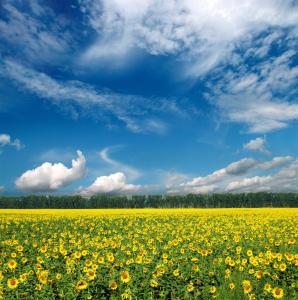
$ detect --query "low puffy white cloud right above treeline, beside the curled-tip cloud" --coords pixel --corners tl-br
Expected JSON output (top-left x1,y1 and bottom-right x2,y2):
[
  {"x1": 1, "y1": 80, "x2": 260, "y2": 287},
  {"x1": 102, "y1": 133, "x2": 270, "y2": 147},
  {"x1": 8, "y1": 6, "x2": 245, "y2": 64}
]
[{"x1": 77, "y1": 172, "x2": 141, "y2": 197}]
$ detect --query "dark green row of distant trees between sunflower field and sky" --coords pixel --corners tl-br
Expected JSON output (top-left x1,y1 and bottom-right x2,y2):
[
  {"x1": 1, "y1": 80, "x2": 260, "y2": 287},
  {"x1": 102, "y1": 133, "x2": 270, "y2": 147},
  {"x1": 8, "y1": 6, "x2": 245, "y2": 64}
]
[{"x1": 0, "y1": 192, "x2": 298, "y2": 208}]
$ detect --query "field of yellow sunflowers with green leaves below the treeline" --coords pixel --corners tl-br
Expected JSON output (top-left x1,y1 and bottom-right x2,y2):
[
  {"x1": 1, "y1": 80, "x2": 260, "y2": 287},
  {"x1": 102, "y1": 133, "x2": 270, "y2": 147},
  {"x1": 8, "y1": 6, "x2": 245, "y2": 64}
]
[{"x1": 0, "y1": 209, "x2": 298, "y2": 300}]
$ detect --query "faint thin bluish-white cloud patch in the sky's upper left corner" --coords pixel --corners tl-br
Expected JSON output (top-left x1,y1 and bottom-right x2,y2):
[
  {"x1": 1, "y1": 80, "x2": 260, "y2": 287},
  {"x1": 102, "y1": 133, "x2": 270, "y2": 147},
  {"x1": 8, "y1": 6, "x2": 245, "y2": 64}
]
[{"x1": 0, "y1": 0, "x2": 75, "y2": 64}]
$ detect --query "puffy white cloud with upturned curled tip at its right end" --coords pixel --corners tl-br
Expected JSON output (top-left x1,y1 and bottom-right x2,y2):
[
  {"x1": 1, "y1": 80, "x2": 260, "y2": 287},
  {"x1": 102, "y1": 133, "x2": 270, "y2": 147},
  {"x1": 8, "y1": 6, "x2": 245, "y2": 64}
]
[{"x1": 15, "y1": 151, "x2": 86, "y2": 192}]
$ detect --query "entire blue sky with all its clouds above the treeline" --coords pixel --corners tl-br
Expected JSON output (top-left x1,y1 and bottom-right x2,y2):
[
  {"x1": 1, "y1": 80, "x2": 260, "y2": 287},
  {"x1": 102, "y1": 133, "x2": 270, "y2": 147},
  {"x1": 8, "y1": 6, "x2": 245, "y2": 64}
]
[{"x1": 0, "y1": 0, "x2": 298, "y2": 197}]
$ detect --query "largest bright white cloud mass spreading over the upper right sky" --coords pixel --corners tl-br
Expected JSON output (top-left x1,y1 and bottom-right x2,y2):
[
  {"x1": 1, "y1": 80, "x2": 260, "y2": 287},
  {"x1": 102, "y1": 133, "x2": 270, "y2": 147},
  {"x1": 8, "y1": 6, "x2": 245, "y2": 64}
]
[{"x1": 77, "y1": 0, "x2": 298, "y2": 133}]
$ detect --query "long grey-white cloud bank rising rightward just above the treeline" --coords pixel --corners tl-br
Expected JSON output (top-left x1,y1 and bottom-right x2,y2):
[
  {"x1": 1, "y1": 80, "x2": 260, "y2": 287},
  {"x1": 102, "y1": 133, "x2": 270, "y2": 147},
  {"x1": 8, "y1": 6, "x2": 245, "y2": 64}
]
[{"x1": 167, "y1": 156, "x2": 298, "y2": 194}]
